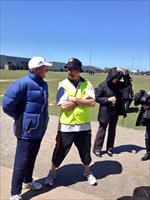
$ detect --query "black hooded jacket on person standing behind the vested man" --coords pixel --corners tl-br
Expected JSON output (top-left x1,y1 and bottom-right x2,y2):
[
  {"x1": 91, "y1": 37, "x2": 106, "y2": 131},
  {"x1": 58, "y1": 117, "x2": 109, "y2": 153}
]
[{"x1": 95, "y1": 68, "x2": 128, "y2": 124}]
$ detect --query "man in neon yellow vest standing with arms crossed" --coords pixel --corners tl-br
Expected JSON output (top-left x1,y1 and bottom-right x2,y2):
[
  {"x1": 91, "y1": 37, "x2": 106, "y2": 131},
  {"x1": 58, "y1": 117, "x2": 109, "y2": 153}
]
[{"x1": 45, "y1": 58, "x2": 97, "y2": 186}]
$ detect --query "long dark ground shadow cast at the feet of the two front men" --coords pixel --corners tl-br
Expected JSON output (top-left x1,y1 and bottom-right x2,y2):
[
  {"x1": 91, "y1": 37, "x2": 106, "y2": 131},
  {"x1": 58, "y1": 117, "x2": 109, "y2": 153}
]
[{"x1": 22, "y1": 160, "x2": 122, "y2": 200}]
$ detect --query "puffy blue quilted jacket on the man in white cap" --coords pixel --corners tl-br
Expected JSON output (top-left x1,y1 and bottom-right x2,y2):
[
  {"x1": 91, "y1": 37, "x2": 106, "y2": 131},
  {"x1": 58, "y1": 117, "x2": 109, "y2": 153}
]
[{"x1": 2, "y1": 72, "x2": 49, "y2": 140}]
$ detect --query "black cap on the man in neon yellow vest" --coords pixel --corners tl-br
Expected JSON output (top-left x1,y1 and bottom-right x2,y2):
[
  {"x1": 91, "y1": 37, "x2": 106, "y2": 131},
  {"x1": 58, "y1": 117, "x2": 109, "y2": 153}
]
[{"x1": 65, "y1": 58, "x2": 83, "y2": 72}]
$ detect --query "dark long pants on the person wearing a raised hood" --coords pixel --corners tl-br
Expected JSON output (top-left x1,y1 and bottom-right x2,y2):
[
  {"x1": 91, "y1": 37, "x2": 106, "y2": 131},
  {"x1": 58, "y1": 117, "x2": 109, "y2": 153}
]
[{"x1": 93, "y1": 113, "x2": 118, "y2": 151}]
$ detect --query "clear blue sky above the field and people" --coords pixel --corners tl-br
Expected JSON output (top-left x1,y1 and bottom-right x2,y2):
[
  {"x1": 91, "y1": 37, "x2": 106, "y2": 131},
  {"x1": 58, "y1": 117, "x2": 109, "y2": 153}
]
[{"x1": 1, "y1": 0, "x2": 150, "y2": 70}]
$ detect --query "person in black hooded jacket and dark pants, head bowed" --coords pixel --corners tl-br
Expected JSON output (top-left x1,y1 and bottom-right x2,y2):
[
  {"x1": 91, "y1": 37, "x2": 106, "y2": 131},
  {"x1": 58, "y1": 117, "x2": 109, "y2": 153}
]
[{"x1": 93, "y1": 68, "x2": 128, "y2": 157}]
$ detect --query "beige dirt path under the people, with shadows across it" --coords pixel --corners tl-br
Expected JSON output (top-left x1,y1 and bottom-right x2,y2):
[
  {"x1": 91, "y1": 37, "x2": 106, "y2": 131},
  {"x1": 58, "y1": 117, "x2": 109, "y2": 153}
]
[{"x1": 0, "y1": 108, "x2": 150, "y2": 200}]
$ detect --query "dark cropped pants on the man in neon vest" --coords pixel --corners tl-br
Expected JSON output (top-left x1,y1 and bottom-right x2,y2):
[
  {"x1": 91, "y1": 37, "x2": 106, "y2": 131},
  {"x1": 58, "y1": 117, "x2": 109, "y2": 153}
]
[{"x1": 52, "y1": 131, "x2": 91, "y2": 167}]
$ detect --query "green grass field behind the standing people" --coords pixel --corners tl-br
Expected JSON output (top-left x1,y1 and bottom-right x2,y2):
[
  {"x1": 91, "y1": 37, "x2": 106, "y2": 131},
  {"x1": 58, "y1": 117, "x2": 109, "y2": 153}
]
[{"x1": 0, "y1": 70, "x2": 150, "y2": 128}]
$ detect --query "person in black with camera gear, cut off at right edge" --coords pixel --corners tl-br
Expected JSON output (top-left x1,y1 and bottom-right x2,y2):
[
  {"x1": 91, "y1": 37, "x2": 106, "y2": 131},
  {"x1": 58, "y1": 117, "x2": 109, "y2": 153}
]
[{"x1": 134, "y1": 90, "x2": 150, "y2": 161}]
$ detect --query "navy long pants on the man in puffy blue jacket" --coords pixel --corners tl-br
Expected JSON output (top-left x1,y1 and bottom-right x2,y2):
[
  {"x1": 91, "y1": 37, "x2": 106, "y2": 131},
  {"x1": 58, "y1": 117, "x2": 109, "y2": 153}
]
[{"x1": 11, "y1": 139, "x2": 41, "y2": 195}]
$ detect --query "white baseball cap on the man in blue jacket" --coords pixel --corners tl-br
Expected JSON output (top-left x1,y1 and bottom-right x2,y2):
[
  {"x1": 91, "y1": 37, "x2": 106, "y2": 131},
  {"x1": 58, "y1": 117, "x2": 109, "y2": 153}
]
[{"x1": 28, "y1": 56, "x2": 53, "y2": 69}]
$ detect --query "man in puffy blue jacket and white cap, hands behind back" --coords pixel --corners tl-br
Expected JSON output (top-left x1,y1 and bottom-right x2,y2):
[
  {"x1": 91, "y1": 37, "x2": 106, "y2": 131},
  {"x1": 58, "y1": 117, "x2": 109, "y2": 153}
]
[{"x1": 2, "y1": 57, "x2": 51, "y2": 200}]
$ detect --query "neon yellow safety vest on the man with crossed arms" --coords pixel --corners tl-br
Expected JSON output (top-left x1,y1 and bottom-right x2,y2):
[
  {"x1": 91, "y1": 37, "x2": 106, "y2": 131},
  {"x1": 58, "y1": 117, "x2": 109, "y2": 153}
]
[{"x1": 60, "y1": 79, "x2": 90, "y2": 124}]
